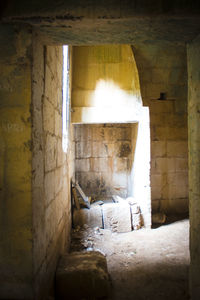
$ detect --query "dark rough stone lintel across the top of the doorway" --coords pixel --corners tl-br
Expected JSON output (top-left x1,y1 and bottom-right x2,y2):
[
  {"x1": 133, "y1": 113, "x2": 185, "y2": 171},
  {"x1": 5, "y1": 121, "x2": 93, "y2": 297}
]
[{"x1": 1, "y1": 0, "x2": 200, "y2": 45}]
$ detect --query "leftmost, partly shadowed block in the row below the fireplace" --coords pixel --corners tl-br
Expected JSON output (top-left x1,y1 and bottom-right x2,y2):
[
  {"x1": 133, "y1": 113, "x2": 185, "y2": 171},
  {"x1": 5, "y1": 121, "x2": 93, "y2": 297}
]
[{"x1": 73, "y1": 205, "x2": 103, "y2": 228}]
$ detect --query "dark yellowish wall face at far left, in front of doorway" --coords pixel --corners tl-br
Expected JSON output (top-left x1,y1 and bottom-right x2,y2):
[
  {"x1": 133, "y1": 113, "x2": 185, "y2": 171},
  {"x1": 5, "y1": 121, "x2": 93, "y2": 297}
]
[{"x1": 0, "y1": 25, "x2": 32, "y2": 299}]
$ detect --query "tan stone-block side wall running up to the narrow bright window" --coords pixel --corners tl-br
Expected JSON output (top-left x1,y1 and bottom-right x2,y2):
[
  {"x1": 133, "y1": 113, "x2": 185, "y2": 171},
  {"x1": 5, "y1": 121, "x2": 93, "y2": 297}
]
[{"x1": 32, "y1": 35, "x2": 71, "y2": 299}]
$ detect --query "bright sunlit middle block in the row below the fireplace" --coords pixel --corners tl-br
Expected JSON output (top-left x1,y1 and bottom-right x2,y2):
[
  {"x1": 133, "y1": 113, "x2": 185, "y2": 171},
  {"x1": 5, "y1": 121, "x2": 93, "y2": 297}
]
[{"x1": 102, "y1": 203, "x2": 131, "y2": 233}]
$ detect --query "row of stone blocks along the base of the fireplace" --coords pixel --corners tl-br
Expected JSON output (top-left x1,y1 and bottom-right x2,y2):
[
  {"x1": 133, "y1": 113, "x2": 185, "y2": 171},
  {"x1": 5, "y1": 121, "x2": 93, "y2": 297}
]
[{"x1": 73, "y1": 196, "x2": 142, "y2": 233}]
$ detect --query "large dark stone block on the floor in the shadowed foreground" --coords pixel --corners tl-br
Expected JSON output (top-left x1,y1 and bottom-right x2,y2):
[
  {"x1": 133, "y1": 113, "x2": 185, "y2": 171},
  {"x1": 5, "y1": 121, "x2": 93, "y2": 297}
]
[{"x1": 56, "y1": 251, "x2": 111, "y2": 300}]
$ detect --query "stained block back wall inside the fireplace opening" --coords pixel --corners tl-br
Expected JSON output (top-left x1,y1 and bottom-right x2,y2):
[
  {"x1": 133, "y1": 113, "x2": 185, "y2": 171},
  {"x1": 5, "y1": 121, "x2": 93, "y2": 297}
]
[{"x1": 74, "y1": 124, "x2": 137, "y2": 200}]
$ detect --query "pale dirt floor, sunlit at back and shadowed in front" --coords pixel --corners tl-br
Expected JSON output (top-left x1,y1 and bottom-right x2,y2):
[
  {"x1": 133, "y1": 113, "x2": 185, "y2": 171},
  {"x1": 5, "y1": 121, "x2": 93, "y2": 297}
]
[{"x1": 71, "y1": 219, "x2": 189, "y2": 300}]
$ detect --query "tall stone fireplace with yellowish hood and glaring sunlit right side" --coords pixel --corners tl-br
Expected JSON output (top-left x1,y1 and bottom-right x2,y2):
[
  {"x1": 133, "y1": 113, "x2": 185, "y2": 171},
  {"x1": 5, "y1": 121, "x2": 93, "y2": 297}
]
[{"x1": 71, "y1": 45, "x2": 151, "y2": 227}]
